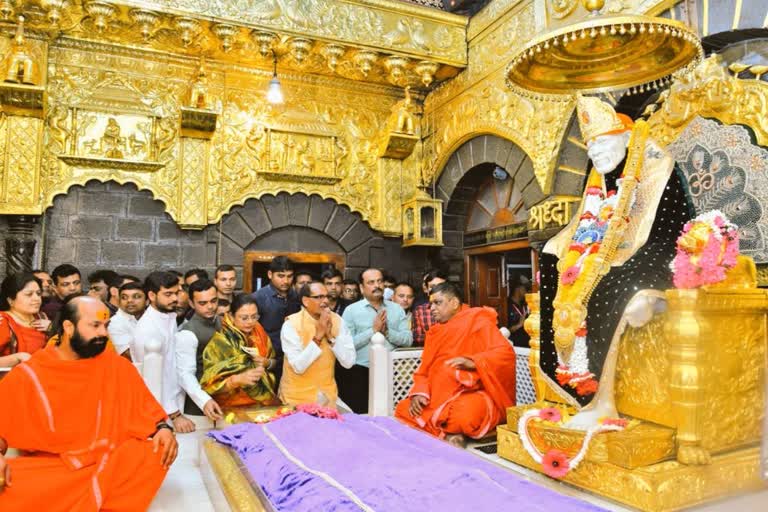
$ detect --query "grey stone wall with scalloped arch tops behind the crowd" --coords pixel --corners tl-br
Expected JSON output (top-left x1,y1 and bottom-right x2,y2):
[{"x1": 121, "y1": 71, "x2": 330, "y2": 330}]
[{"x1": 39, "y1": 181, "x2": 426, "y2": 285}]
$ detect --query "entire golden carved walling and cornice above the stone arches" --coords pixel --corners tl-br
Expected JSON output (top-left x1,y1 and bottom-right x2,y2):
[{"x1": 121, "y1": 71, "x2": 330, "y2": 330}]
[{"x1": 0, "y1": 0, "x2": 752, "y2": 235}]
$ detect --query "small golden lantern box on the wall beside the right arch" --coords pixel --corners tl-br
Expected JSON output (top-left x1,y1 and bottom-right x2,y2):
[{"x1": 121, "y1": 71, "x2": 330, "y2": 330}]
[{"x1": 403, "y1": 190, "x2": 443, "y2": 247}]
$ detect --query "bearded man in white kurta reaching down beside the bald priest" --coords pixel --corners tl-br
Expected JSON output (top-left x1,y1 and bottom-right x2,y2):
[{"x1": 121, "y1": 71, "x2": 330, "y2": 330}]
[{"x1": 131, "y1": 271, "x2": 195, "y2": 433}]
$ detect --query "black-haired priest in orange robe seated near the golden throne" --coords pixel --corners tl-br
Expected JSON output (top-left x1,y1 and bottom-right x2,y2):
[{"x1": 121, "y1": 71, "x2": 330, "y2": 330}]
[{"x1": 395, "y1": 282, "x2": 515, "y2": 446}]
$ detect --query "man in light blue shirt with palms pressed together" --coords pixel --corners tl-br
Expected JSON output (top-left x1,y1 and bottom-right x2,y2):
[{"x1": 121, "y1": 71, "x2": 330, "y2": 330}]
[{"x1": 337, "y1": 268, "x2": 413, "y2": 414}]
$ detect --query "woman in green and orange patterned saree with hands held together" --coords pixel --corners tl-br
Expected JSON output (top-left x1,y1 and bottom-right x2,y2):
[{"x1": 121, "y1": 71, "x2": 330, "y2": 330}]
[{"x1": 200, "y1": 294, "x2": 280, "y2": 407}]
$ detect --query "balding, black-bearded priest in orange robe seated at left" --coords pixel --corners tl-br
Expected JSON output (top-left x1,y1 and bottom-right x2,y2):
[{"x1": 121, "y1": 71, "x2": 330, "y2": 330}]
[{"x1": 0, "y1": 297, "x2": 177, "y2": 512}]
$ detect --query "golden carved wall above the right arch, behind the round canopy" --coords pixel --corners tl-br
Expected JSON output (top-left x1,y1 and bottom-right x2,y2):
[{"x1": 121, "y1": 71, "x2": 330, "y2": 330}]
[{"x1": 424, "y1": 0, "x2": 674, "y2": 194}]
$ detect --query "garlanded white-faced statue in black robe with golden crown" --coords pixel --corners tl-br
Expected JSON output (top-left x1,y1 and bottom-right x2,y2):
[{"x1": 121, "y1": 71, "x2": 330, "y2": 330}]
[{"x1": 540, "y1": 97, "x2": 692, "y2": 430}]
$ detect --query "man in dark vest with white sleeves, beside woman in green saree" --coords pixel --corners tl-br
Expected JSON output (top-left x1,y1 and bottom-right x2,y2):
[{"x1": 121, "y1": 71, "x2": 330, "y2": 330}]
[{"x1": 176, "y1": 279, "x2": 222, "y2": 421}]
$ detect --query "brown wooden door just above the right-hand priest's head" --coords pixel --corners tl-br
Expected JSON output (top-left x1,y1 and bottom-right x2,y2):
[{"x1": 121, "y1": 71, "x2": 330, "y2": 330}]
[{"x1": 468, "y1": 253, "x2": 507, "y2": 325}]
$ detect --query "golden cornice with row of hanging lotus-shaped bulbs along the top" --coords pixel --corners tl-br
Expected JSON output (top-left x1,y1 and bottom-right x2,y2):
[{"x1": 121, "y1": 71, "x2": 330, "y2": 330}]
[{"x1": 7, "y1": 0, "x2": 468, "y2": 89}]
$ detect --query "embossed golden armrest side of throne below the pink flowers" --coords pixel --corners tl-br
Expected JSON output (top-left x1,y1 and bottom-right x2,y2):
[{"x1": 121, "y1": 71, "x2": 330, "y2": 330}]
[{"x1": 616, "y1": 289, "x2": 768, "y2": 452}]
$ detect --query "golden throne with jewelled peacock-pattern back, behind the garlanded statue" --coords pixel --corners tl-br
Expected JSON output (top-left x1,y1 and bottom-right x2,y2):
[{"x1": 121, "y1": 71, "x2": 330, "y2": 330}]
[{"x1": 498, "y1": 57, "x2": 768, "y2": 511}]
